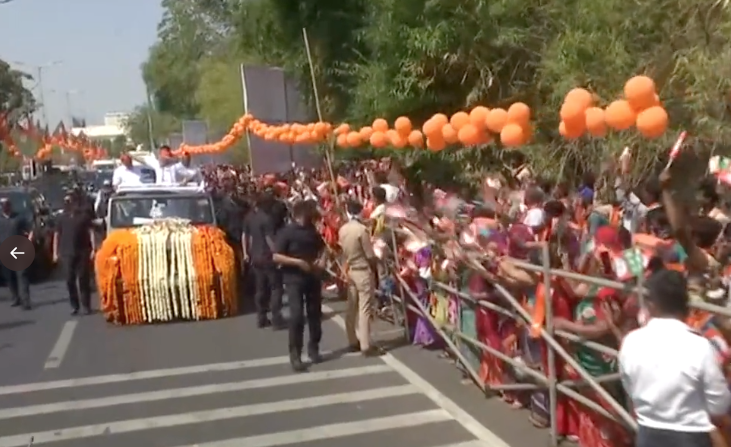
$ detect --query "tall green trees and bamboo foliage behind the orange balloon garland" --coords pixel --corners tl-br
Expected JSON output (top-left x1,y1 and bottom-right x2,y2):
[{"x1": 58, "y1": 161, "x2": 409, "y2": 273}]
[{"x1": 136, "y1": 0, "x2": 731, "y2": 187}]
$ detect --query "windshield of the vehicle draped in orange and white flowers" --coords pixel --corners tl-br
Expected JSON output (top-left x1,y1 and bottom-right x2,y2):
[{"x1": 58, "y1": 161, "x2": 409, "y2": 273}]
[{"x1": 109, "y1": 195, "x2": 214, "y2": 228}]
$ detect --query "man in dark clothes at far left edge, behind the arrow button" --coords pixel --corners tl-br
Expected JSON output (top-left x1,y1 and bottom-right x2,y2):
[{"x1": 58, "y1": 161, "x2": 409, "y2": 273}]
[{"x1": 0, "y1": 198, "x2": 33, "y2": 310}]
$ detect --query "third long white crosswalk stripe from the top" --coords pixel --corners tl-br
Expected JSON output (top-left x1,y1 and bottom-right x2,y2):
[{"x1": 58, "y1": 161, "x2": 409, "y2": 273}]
[{"x1": 0, "y1": 385, "x2": 420, "y2": 447}]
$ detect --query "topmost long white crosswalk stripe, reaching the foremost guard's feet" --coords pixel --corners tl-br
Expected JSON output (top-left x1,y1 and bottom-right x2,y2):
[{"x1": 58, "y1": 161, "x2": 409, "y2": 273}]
[{"x1": 0, "y1": 352, "x2": 357, "y2": 396}]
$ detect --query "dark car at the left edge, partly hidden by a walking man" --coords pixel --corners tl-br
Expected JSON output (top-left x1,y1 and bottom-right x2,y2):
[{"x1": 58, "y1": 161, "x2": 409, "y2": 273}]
[{"x1": 0, "y1": 186, "x2": 54, "y2": 281}]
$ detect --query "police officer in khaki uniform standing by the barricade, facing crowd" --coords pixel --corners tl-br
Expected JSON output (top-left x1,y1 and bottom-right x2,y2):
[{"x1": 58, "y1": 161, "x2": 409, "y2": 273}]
[{"x1": 338, "y1": 201, "x2": 381, "y2": 357}]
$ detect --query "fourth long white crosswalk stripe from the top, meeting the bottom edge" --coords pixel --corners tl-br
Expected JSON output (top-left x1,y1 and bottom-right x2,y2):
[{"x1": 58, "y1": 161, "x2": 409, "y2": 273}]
[{"x1": 177, "y1": 409, "x2": 452, "y2": 447}]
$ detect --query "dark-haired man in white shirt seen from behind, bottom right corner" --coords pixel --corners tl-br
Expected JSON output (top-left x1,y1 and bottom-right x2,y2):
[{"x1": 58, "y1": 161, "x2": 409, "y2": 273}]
[{"x1": 619, "y1": 270, "x2": 731, "y2": 447}]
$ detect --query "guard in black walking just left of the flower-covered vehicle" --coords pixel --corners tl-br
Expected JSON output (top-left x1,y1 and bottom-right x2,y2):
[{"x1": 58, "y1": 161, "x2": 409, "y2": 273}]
[{"x1": 53, "y1": 194, "x2": 94, "y2": 315}]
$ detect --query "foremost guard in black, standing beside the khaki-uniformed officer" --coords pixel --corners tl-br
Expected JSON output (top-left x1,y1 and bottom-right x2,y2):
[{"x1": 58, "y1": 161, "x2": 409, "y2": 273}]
[{"x1": 273, "y1": 201, "x2": 325, "y2": 372}]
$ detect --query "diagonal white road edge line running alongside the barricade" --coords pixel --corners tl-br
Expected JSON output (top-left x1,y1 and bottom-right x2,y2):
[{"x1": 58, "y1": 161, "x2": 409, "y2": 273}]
[{"x1": 324, "y1": 305, "x2": 510, "y2": 447}]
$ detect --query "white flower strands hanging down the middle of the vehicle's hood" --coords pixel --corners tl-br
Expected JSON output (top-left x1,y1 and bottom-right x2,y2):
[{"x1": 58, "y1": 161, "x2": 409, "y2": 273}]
[{"x1": 134, "y1": 219, "x2": 200, "y2": 323}]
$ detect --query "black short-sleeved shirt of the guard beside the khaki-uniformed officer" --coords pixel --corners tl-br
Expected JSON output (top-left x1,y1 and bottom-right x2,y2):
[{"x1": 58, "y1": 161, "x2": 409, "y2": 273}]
[{"x1": 274, "y1": 222, "x2": 325, "y2": 279}]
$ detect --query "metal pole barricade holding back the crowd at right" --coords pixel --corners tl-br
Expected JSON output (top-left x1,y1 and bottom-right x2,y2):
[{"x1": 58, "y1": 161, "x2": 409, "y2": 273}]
[{"x1": 336, "y1": 228, "x2": 731, "y2": 446}]
